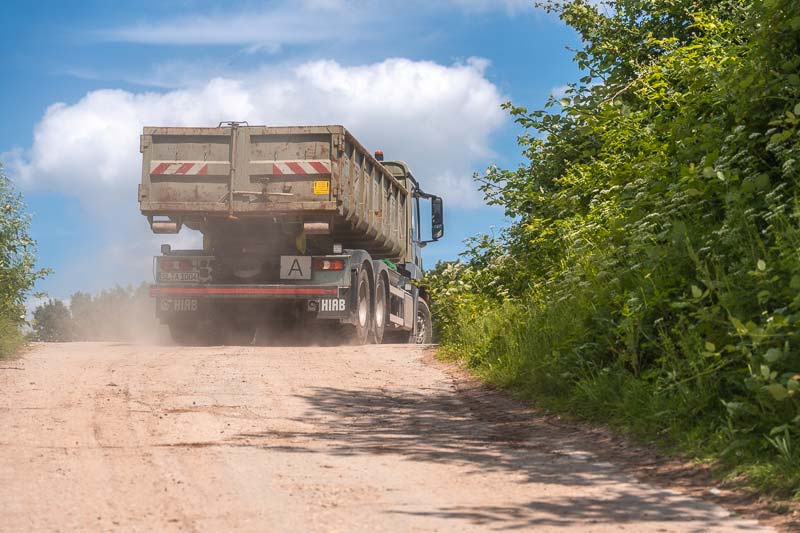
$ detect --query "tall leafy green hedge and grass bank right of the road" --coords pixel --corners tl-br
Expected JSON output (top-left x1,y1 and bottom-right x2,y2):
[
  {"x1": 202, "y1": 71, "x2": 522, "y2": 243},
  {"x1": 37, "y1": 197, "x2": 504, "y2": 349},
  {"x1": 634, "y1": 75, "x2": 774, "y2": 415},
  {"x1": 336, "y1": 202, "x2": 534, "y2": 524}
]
[{"x1": 428, "y1": 0, "x2": 800, "y2": 497}]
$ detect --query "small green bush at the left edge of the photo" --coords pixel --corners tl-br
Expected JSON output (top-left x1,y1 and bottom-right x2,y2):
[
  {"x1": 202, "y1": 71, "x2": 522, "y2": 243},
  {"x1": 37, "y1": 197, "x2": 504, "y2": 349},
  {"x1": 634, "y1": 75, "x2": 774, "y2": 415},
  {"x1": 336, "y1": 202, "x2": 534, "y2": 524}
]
[{"x1": 0, "y1": 165, "x2": 47, "y2": 357}]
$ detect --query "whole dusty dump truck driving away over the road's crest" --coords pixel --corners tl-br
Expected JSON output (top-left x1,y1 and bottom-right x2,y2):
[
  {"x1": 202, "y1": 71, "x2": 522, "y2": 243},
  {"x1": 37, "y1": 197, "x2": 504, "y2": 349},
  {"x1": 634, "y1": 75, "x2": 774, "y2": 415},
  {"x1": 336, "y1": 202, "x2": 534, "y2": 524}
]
[{"x1": 138, "y1": 122, "x2": 444, "y2": 344}]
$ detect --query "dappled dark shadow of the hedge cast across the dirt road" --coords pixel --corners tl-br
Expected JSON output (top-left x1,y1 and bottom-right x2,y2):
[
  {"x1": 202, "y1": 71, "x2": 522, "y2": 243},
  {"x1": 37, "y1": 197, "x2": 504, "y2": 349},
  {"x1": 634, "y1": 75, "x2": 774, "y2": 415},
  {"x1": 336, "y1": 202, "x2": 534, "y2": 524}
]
[{"x1": 238, "y1": 387, "x2": 751, "y2": 531}]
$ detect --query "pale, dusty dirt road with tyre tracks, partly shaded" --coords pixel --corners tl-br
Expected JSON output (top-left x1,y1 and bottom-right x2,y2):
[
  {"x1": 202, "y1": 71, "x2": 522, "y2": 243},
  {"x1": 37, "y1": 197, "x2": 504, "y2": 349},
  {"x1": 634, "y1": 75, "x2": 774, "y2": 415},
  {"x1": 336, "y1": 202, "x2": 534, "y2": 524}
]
[{"x1": 0, "y1": 343, "x2": 776, "y2": 532}]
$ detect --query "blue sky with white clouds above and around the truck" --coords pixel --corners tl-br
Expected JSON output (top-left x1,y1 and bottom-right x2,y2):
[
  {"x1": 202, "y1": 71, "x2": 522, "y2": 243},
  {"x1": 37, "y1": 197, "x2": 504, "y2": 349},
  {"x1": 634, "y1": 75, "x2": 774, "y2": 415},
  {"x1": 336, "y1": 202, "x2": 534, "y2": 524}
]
[{"x1": 0, "y1": 0, "x2": 580, "y2": 298}]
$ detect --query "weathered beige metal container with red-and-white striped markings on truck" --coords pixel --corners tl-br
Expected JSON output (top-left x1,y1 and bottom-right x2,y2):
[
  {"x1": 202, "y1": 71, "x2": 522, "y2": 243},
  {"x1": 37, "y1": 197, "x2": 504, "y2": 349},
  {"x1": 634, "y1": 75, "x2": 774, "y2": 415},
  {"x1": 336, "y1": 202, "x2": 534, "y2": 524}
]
[{"x1": 139, "y1": 123, "x2": 412, "y2": 261}]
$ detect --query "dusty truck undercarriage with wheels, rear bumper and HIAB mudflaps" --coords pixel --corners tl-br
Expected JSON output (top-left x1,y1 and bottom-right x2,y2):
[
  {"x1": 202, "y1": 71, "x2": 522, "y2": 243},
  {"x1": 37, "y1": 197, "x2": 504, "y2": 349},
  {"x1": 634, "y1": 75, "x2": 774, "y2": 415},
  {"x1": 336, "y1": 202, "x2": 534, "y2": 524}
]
[{"x1": 150, "y1": 250, "x2": 432, "y2": 344}]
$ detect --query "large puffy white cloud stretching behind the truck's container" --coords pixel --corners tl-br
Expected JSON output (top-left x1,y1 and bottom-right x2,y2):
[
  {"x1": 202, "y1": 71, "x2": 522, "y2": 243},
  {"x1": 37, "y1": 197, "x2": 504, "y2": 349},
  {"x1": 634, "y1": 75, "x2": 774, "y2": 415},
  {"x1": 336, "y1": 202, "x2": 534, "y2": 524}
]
[{"x1": 2, "y1": 59, "x2": 505, "y2": 296}]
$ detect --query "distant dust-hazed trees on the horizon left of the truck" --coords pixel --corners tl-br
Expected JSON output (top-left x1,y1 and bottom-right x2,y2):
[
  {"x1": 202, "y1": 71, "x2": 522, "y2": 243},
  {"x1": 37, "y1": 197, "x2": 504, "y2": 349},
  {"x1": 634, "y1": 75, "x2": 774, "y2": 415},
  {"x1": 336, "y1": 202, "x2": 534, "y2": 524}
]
[{"x1": 31, "y1": 283, "x2": 161, "y2": 342}]
